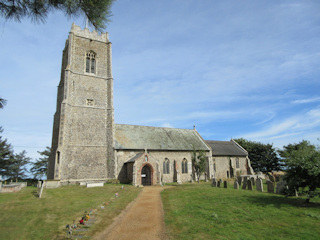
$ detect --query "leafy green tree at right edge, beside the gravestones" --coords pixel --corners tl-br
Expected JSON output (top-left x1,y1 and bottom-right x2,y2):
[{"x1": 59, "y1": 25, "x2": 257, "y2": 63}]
[{"x1": 279, "y1": 140, "x2": 320, "y2": 201}]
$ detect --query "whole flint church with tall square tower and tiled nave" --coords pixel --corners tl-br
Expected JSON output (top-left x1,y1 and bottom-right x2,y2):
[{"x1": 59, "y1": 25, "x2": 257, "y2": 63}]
[{"x1": 47, "y1": 24, "x2": 253, "y2": 186}]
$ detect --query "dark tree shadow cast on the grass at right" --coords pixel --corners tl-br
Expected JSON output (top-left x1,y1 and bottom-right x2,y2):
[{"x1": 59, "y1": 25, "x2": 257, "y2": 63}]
[{"x1": 247, "y1": 194, "x2": 320, "y2": 209}]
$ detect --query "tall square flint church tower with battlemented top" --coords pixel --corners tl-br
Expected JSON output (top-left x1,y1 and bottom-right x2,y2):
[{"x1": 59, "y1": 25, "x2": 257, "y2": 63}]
[{"x1": 48, "y1": 24, "x2": 115, "y2": 182}]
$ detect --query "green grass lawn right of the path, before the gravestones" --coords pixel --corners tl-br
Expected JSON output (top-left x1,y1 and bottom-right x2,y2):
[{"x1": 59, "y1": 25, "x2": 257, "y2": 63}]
[{"x1": 162, "y1": 183, "x2": 320, "y2": 240}]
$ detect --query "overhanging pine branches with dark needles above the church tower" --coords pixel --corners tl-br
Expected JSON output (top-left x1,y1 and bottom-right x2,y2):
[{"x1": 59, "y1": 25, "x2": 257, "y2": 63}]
[{"x1": 0, "y1": 0, "x2": 114, "y2": 31}]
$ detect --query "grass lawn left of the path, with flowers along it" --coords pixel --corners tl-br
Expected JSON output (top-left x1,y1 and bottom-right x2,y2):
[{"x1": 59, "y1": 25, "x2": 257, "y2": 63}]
[{"x1": 0, "y1": 184, "x2": 140, "y2": 239}]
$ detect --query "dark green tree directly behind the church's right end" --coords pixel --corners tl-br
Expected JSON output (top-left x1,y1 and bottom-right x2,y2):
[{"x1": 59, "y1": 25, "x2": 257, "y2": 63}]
[{"x1": 235, "y1": 138, "x2": 282, "y2": 174}]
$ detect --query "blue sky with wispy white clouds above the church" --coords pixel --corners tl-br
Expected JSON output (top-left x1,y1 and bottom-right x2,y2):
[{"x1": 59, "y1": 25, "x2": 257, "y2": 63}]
[{"x1": 0, "y1": 0, "x2": 320, "y2": 161}]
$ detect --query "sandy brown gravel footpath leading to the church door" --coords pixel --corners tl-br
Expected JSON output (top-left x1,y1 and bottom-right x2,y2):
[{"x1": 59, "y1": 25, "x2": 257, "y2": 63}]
[{"x1": 94, "y1": 186, "x2": 165, "y2": 240}]
